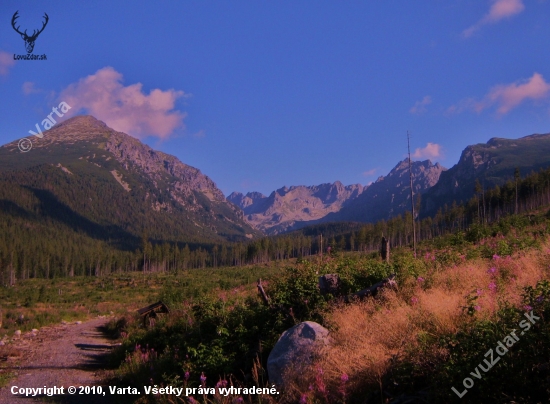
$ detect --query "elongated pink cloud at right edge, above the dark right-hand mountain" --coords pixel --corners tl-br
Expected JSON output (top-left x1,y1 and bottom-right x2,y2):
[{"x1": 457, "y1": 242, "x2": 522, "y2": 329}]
[{"x1": 447, "y1": 73, "x2": 550, "y2": 115}]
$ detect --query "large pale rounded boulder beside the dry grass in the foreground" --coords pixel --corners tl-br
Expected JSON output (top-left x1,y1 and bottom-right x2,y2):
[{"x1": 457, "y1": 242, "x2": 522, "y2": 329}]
[{"x1": 267, "y1": 321, "x2": 329, "y2": 386}]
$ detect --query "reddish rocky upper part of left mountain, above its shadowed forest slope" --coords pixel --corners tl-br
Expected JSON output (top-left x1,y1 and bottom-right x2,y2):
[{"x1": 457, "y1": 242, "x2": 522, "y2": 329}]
[{"x1": 0, "y1": 115, "x2": 257, "y2": 239}]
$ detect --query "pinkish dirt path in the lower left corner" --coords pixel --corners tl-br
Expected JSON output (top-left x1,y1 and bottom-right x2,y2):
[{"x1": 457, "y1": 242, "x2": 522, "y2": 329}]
[{"x1": 0, "y1": 318, "x2": 124, "y2": 404}]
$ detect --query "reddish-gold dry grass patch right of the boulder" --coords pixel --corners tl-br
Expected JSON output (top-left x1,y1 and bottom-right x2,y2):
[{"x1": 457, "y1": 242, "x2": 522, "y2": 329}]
[{"x1": 294, "y1": 241, "x2": 550, "y2": 402}]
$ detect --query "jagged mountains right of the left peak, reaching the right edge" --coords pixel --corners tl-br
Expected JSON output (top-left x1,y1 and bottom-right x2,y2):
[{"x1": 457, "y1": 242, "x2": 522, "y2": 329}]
[{"x1": 228, "y1": 134, "x2": 550, "y2": 234}]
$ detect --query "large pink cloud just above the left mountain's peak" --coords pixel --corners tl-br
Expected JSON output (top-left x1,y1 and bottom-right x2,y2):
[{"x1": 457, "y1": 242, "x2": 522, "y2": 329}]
[{"x1": 59, "y1": 67, "x2": 186, "y2": 139}]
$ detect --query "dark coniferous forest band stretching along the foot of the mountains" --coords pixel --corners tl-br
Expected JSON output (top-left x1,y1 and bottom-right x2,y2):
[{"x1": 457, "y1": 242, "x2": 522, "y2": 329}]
[{"x1": 0, "y1": 167, "x2": 550, "y2": 285}]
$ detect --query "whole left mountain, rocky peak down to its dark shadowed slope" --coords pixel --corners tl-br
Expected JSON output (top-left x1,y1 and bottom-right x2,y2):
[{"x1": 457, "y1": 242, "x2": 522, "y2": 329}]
[{"x1": 0, "y1": 116, "x2": 258, "y2": 249}]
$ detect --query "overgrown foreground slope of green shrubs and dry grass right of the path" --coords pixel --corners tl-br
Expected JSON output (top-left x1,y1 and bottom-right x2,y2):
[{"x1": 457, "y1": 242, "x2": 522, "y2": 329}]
[{"x1": 101, "y1": 212, "x2": 550, "y2": 403}]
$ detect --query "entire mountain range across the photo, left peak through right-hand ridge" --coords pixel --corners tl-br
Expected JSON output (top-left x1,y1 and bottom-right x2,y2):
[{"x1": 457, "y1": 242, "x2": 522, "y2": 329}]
[{"x1": 0, "y1": 116, "x2": 550, "y2": 246}]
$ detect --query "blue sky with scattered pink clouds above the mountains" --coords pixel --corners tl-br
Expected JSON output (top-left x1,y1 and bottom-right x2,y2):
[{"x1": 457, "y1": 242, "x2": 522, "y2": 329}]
[{"x1": 0, "y1": 0, "x2": 550, "y2": 195}]
